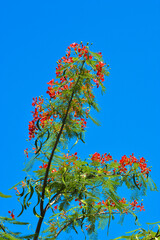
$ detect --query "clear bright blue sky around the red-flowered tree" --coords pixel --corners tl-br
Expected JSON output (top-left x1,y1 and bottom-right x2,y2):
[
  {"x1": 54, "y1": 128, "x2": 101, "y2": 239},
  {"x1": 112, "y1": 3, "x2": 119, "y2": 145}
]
[{"x1": 0, "y1": 0, "x2": 160, "y2": 240}]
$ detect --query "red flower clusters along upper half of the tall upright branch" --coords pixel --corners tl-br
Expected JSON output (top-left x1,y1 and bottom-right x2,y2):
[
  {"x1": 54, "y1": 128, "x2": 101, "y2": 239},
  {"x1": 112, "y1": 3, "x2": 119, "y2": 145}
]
[{"x1": 27, "y1": 43, "x2": 105, "y2": 141}]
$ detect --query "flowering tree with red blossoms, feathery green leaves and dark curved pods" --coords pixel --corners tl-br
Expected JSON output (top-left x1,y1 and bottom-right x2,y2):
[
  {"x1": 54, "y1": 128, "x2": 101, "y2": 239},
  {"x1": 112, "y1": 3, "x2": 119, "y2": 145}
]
[{"x1": 0, "y1": 43, "x2": 158, "y2": 240}]
